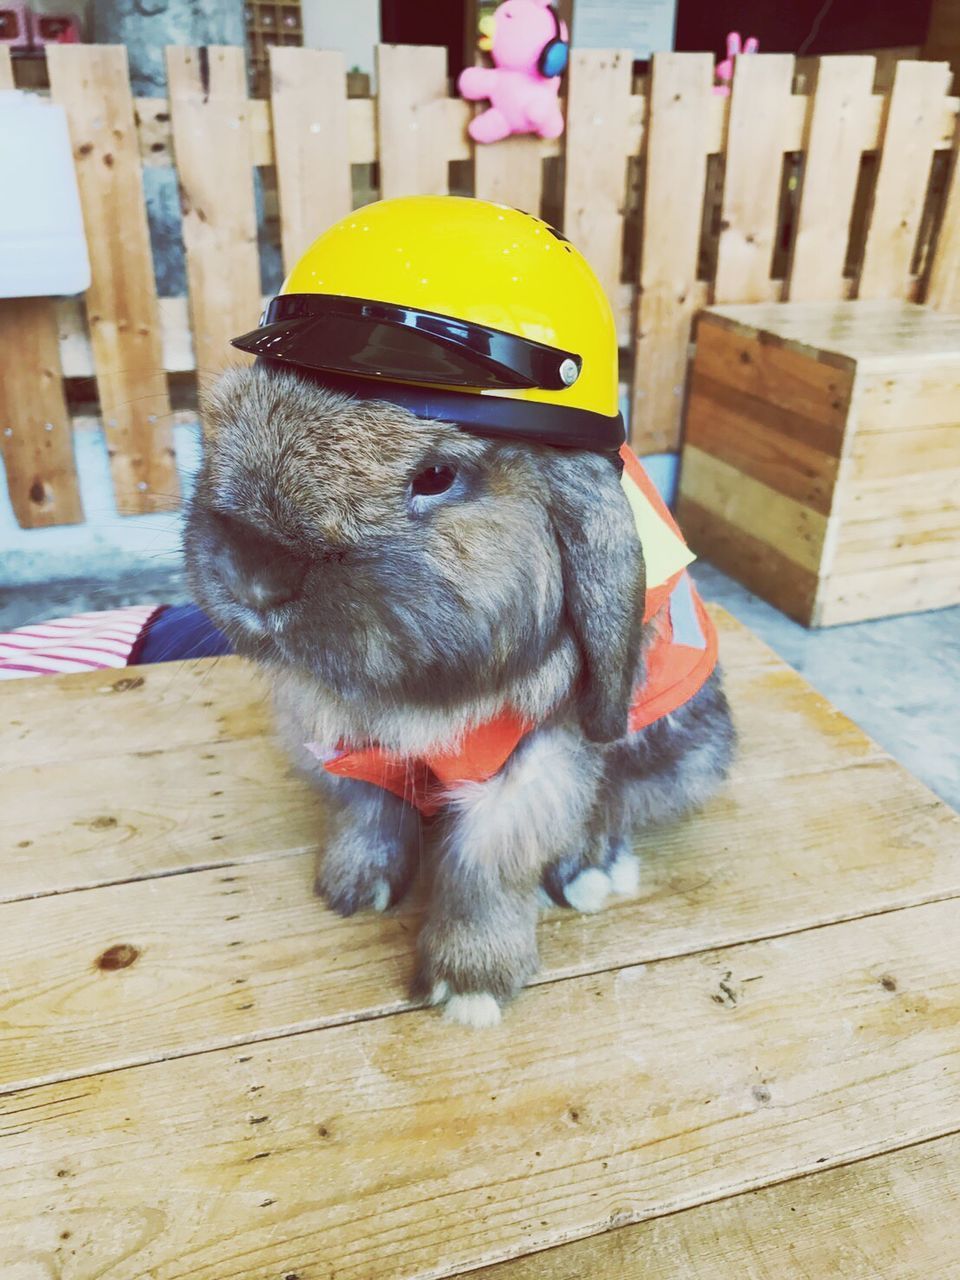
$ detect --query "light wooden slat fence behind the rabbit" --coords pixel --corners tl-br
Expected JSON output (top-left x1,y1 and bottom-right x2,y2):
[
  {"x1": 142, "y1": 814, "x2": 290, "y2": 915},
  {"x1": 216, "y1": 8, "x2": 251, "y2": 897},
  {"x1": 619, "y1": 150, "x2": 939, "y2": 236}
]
[{"x1": 0, "y1": 45, "x2": 960, "y2": 526}]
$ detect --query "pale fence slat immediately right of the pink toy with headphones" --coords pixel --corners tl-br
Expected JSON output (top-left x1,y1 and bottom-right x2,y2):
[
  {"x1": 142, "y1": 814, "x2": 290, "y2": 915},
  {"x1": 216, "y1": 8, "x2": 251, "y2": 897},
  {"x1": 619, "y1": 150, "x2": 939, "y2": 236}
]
[{"x1": 563, "y1": 49, "x2": 634, "y2": 305}]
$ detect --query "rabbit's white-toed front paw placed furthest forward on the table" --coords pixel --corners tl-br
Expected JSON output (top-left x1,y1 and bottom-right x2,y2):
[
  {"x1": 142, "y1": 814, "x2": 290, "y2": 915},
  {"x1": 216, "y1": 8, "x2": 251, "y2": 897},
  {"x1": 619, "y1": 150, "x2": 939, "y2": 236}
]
[{"x1": 415, "y1": 920, "x2": 538, "y2": 1027}]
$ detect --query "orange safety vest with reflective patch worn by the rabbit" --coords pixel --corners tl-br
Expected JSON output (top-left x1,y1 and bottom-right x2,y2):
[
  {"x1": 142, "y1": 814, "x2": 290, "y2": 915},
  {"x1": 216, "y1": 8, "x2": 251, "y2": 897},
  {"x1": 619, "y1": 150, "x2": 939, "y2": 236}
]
[{"x1": 307, "y1": 445, "x2": 717, "y2": 817}]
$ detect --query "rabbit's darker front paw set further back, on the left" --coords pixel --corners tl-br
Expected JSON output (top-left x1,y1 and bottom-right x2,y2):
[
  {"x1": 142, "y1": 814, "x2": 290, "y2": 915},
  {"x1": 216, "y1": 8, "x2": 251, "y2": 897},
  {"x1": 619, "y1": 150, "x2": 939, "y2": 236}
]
[{"x1": 315, "y1": 828, "x2": 412, "y2": 915}]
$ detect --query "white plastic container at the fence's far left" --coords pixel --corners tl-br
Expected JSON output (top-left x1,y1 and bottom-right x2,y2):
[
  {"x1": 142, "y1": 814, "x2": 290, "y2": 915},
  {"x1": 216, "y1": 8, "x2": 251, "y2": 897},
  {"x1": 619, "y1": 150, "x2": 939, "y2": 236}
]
[{"x1": 0, "y1": 90, "x2": 90, "y2": 298}]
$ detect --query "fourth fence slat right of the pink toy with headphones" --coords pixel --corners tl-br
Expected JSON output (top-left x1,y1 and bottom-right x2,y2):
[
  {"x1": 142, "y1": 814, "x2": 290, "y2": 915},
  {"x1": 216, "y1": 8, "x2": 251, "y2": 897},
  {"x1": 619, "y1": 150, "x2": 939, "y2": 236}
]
[{"x1": 783, "y1": 56, "x2": 876, "y2": 300}]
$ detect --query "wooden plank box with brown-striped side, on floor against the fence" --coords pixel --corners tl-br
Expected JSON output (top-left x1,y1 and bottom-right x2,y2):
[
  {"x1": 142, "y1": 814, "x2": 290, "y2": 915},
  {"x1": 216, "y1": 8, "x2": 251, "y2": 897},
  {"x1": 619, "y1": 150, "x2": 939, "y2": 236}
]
[{"x1": 680, "y1": 301, "x2": 960, "y2": 626}]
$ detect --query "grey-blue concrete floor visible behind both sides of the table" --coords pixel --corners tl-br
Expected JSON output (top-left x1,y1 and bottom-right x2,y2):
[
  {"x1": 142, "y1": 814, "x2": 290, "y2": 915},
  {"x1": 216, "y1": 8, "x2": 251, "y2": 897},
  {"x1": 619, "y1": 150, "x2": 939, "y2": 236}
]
[{"x1": 0, "y1": 561, "x2": 960, "y2": 809}]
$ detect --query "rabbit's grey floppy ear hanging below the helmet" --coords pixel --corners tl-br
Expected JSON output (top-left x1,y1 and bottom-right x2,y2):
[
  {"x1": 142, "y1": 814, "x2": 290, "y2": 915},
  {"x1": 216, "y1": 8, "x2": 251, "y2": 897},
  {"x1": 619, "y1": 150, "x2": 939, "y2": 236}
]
[{"x1": 548, "y1": 452, "x2": 645, "y2": 742}]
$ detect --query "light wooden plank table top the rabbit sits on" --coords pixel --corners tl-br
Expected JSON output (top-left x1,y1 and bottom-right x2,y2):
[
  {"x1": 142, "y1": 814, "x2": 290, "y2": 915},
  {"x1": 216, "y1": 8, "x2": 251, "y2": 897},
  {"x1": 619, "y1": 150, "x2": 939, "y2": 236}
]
[{"x1": 0, "y1": 613, "x2": 960, "y2": 1280}]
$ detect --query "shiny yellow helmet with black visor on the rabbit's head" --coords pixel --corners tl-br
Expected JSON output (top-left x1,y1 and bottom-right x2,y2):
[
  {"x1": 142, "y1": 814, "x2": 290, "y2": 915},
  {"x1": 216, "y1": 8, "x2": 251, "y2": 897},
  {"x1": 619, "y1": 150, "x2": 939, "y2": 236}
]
[{"x1": 233, "y1": 196, "x2": 623, "y2": 454}]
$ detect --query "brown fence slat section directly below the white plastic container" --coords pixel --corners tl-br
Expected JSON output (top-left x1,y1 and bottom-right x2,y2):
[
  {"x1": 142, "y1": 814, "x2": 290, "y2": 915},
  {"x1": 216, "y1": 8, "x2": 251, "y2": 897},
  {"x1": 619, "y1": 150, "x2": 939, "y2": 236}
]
[{"x1": 0, "y1": 296, "x2": 83, "y2": 529}]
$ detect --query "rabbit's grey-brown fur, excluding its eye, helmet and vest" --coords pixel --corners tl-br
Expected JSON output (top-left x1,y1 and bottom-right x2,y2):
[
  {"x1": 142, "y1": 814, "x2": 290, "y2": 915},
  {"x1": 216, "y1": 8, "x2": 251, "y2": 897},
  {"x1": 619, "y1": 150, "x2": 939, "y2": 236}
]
[{"x1": 186, "y1": 369, "x2": 732, "y2": 1011}]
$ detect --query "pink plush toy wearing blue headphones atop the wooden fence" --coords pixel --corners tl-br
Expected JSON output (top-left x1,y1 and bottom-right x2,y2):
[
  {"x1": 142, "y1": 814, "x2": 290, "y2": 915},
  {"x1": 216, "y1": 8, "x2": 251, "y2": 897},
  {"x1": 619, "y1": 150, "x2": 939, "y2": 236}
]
[{"x1": 457, "y1": 0, "x2": 570, "y2": 142}]
